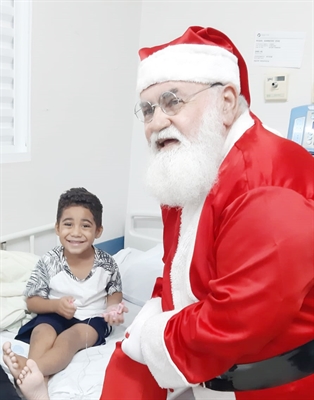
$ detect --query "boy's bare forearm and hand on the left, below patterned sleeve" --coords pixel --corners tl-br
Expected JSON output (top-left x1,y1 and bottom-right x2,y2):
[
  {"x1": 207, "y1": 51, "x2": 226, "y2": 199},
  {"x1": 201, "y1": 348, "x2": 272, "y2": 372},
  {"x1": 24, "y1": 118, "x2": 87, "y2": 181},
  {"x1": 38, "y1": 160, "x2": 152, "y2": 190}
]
[{"x1": 26, "y1": 296, "x2": 76, "y2": 319}]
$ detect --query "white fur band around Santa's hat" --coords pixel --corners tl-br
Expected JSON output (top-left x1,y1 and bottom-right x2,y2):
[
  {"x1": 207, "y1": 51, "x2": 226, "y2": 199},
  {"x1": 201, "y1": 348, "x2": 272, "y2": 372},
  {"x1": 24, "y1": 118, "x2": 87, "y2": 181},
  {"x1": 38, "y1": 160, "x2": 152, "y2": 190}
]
[{"x1": 137, "y1": 44, "x2": 240, "y2": 93}]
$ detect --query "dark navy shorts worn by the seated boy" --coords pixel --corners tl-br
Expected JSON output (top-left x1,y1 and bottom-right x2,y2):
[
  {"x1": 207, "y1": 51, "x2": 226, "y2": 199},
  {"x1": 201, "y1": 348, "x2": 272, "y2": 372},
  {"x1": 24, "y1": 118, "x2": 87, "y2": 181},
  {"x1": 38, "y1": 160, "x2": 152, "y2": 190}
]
[{"x1": 15, "y1": 313, "x2": 112, "y2": 346}]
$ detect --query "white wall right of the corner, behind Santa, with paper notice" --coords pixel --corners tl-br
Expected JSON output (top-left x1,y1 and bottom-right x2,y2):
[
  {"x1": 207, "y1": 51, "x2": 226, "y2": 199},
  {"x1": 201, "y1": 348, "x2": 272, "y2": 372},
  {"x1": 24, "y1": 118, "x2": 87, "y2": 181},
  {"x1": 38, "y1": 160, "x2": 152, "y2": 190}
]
[{"x1": 126, "y1": 0, "x2": 314, "y2": 244}]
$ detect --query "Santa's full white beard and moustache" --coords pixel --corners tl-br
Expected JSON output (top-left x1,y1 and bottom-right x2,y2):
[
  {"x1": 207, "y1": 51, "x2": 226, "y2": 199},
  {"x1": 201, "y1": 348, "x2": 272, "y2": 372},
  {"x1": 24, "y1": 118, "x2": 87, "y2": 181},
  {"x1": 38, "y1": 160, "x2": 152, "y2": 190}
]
[{"x1": 146, "y1": 104, "x2": 225, "y2": 207}]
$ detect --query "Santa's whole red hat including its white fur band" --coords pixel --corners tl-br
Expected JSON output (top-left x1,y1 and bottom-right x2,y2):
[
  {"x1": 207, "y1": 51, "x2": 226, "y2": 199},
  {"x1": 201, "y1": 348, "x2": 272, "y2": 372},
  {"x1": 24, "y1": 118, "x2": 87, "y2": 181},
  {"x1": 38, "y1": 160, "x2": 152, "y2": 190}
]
[{"x1": 137, "y1": 26, "x2": 250, "y2": 104}]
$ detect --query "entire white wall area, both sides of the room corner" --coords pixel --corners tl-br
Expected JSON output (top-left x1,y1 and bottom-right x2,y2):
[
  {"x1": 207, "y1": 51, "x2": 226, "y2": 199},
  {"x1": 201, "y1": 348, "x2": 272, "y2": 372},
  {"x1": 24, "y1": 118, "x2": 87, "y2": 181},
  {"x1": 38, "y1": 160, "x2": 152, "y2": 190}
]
[{"x1": 0, "y1": 0, "x2": 314, "y2": 250}]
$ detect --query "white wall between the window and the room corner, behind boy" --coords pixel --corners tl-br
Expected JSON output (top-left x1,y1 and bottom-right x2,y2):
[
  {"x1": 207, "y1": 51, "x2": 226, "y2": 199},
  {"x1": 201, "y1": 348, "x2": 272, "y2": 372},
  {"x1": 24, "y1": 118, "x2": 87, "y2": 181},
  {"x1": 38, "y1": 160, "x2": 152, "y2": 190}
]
[{"x1": 0, "y1": 0, "x2": 141, "y2": 241}]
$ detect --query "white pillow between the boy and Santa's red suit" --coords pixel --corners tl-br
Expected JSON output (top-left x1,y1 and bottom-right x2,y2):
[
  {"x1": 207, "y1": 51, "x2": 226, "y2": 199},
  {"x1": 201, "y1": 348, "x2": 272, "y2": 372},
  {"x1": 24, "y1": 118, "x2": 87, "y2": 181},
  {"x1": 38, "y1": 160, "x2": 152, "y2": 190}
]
[{"x1": 113, "y1": 243, "x2": 163, "y2": 306}]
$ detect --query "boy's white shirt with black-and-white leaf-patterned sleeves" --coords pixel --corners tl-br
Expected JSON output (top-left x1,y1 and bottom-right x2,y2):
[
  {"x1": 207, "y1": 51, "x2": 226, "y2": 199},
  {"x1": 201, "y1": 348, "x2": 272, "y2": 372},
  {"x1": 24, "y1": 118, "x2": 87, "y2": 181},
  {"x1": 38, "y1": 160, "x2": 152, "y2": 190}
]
[{"x1": 24, "y1": 246, "x2": 122, "y2": 320}]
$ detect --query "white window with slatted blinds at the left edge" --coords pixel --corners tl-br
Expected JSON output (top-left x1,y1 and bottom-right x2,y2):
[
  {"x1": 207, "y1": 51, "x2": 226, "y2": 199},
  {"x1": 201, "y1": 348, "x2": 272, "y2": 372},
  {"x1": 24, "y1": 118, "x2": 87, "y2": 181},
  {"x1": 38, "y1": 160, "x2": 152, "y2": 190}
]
[{"x1": 0, "y1": 0, "x2": 31, "y2": 163}]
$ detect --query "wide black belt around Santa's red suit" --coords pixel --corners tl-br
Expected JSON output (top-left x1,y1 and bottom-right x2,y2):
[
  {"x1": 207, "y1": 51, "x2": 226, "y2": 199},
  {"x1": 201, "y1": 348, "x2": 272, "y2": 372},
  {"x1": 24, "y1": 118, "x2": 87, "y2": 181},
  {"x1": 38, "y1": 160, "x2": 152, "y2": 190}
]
[{"x1": 201, "y1": 340, "x2": 314, "y2": 392}]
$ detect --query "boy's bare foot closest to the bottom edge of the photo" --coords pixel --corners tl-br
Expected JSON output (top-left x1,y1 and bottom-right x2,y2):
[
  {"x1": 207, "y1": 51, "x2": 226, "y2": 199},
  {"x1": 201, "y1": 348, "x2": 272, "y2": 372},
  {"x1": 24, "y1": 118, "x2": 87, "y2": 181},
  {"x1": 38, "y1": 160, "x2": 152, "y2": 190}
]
[{"x1": 16, "y1": 359, "x2": 49, "y2": 400}]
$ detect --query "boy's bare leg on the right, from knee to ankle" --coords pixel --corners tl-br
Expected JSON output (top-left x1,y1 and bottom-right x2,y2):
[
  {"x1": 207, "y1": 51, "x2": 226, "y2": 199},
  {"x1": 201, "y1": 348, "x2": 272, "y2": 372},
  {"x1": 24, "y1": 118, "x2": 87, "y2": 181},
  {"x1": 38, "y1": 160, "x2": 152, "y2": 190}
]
[{"x1": 35, "y1": 323, "x2": 98, "y2": 376}]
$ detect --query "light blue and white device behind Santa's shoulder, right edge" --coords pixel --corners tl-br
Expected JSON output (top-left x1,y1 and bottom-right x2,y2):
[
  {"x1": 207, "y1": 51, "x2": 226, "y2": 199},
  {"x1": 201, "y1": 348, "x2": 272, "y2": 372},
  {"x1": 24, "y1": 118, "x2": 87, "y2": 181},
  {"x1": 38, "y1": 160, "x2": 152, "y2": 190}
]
[{"x1": 288, "y1": 104, "x2": 314, "y2": 155}]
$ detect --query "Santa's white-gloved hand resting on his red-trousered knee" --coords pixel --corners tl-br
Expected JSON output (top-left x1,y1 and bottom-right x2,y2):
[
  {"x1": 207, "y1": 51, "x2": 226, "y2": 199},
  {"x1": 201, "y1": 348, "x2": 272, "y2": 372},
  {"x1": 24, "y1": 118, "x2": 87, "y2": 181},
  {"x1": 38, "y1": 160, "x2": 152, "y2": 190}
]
[{"x1": 121, "y1": 297, "x2": 162, "y2": 364}]
